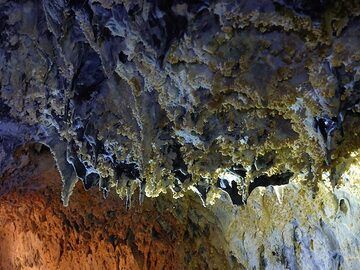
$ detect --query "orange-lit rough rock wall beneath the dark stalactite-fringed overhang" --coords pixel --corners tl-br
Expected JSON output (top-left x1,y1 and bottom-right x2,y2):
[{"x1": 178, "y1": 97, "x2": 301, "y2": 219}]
[{"x1": 0, "y1": 145, "x2": 238, "y2": 270}]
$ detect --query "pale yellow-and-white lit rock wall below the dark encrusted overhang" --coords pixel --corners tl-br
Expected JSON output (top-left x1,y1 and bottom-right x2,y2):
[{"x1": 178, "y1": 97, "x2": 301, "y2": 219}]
[{"x1": 213, "y1": 172, "x2": 360, "y2": 269}]
